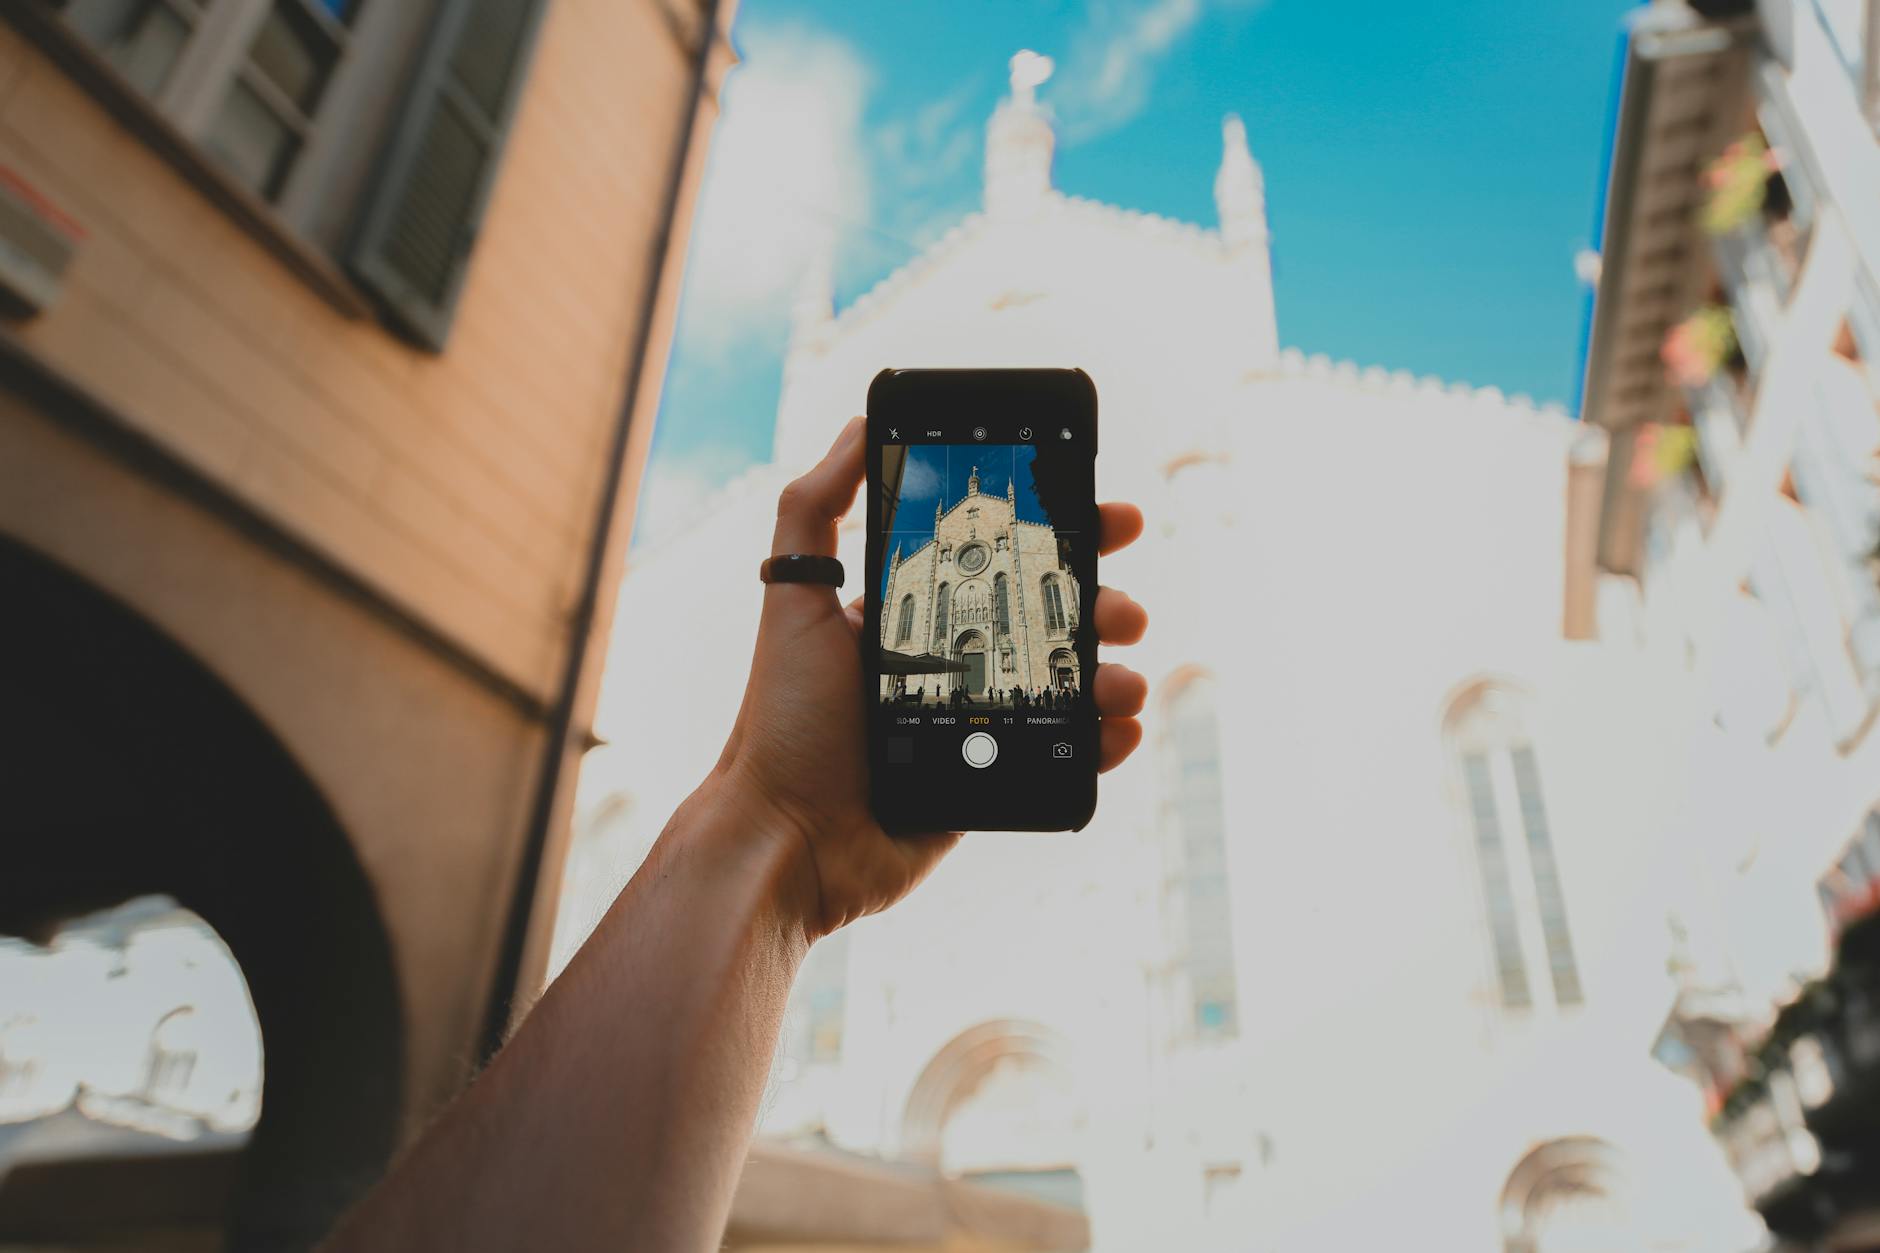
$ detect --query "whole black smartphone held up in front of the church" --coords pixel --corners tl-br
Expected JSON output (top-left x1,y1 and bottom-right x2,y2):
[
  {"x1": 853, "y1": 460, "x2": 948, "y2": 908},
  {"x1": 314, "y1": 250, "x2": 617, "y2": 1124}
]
[{"x1": 861, "y1": 369, "x2": 1098, "y2": 833}]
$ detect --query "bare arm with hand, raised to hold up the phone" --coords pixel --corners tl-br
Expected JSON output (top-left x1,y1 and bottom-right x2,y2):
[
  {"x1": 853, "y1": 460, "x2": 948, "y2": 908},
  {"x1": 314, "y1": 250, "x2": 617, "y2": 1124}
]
[{"x1": 319, "y1": 420, "x2": 1147, "y2": 1253}]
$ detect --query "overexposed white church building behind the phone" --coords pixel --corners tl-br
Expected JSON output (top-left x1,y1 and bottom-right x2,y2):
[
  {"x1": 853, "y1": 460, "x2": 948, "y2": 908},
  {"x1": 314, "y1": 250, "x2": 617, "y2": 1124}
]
[{"x1": 558, "y1": 48, "x2": 1756, "y2": 1253}]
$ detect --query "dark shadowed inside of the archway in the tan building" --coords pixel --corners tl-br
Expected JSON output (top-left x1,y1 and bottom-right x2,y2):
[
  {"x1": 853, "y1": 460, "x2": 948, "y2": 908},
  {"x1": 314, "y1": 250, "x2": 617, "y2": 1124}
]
[{"x1": 0, "y1": 540, "x2": 404, "y2": 1249}]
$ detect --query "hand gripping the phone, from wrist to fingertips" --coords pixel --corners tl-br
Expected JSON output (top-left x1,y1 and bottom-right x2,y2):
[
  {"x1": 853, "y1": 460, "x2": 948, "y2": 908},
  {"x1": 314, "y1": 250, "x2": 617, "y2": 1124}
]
[{"x1": 714, "y1": 418, "x2": 1149, "y2": 939}]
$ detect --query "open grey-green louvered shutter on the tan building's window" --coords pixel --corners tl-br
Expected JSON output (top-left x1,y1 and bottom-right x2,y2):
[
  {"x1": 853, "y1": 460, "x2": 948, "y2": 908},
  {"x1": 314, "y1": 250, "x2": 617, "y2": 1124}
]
[{"x1": 348, "y1": 0, "x2": 547, "y2": 350}]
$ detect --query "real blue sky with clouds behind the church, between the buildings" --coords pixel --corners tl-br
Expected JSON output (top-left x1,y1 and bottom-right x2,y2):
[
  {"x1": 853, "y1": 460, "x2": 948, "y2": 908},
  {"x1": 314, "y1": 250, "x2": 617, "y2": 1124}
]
[{"x1": 637, "y1": 0, "x2": 1632, "y2": 540}]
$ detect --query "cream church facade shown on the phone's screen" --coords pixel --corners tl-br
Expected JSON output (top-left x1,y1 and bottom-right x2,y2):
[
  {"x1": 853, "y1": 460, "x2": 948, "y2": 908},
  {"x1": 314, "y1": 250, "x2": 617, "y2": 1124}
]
[{"x1": 882, "y1": 467, "x2": 1079, "y2": 704}]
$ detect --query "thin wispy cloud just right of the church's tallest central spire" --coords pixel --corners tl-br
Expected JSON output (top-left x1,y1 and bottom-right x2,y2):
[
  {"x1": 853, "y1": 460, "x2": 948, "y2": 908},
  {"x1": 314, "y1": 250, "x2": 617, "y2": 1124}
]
[{"x1": 1045, "y1": 0, "x2": 1201, "y2": 143}]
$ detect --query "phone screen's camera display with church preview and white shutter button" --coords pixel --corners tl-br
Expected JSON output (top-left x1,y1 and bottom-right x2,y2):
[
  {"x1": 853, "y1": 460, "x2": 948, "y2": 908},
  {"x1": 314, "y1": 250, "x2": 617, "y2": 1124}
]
[{"x1": 876, "y1": 438, "x2": 1089, "y2": 769}]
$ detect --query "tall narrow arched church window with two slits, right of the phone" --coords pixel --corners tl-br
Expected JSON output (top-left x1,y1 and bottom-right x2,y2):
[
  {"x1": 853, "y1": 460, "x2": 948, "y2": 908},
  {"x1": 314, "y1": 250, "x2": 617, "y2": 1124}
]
[{"x1": 1444, "y1": 685, "x2": 1583, "y2": 1008}]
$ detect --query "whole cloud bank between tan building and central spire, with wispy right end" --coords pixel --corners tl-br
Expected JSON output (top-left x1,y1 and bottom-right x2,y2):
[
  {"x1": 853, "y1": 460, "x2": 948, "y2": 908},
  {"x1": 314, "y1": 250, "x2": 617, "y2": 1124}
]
[{"x1": 654, "y1": 24, "x2": 987, "y2": 526}]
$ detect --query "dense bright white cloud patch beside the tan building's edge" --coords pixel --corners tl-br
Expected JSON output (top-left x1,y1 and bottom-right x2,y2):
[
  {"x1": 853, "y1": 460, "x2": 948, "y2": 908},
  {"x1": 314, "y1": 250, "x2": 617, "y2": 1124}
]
[{"x1": 681, "y1": 26, "x2": 869, "y2": 354}]
